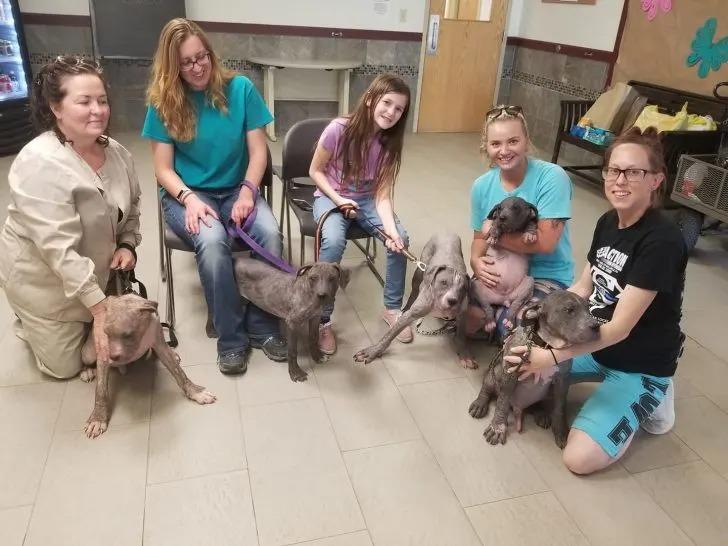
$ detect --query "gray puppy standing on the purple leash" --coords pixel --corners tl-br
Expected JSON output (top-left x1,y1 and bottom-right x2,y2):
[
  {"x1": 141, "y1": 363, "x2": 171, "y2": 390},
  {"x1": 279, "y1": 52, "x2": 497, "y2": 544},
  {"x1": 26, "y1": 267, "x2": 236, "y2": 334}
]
[{"x1": 235, "y1": 258, "x2": 349, "y2": 381}]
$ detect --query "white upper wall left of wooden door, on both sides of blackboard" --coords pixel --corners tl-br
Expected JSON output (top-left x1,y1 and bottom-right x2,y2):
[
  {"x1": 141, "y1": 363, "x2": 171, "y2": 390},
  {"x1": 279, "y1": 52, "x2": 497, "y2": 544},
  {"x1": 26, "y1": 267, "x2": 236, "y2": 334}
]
[{"x1": 20, "y1": 0, "x2": 426, "y2": 32}]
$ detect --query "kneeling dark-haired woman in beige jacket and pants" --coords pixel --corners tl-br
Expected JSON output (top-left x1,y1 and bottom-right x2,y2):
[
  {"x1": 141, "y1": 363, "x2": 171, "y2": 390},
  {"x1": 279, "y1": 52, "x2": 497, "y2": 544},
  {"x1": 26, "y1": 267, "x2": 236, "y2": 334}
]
[{"x1": 0, "y1": 57, "x2": 141, "y2": 379}]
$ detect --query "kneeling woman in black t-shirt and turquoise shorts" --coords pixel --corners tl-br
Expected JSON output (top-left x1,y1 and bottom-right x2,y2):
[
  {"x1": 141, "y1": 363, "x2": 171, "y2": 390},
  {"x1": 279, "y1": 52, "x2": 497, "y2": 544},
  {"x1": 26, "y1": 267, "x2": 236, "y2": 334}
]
[{"x1": 506, "y1": 128, "x2": 687, "y2": 474}]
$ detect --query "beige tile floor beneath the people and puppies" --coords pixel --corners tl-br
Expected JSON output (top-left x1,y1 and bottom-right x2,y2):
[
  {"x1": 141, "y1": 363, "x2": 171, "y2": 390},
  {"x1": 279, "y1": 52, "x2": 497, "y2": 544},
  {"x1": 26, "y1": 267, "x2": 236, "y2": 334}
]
[{"x1": 0, "y1": 135, "x2": 728, "y2": 546}]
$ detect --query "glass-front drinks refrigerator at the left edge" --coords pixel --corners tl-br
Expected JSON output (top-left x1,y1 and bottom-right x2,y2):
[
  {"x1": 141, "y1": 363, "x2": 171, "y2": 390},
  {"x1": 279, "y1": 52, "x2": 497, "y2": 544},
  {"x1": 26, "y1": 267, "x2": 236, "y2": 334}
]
[{"x1": 0, "y1": 0, "x2": 33, "y2": 155}]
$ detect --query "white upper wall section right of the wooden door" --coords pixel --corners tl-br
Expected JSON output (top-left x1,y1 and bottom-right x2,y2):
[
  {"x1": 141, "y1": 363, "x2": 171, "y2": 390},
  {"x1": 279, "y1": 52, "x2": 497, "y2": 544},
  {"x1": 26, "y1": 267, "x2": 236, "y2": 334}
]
[{"x1": 508, "y1": 0, "x2": 624, "y2": 51}]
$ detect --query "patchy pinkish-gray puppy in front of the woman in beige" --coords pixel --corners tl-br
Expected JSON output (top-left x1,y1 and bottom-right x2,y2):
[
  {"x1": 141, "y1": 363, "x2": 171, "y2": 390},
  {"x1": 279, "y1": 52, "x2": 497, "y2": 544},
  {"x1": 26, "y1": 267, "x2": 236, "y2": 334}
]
[{"x1": 81, "y1": 294, "x2": 216, "y2": 438}]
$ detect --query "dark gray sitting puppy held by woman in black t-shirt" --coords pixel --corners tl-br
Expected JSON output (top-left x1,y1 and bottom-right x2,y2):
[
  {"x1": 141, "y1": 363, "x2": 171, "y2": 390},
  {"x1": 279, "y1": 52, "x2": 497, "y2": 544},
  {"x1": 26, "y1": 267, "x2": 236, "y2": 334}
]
[{"x1": 468, "y1": 290, "x2": 599, "y2": 448}]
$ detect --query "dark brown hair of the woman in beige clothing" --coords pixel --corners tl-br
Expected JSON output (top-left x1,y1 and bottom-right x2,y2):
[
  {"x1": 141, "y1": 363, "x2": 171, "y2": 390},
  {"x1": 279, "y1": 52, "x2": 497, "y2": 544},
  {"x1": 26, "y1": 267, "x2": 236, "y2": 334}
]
[{"x1": 30, "y1": 55, "x2": 109, "y2": 146}]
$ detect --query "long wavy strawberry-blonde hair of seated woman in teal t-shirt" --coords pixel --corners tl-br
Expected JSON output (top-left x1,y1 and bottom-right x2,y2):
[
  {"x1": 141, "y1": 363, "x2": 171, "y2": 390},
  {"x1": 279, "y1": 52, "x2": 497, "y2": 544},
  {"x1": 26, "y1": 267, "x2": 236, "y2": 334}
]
[{"x1": 147, "y1": 18, "x2": 235, "y2": 142}]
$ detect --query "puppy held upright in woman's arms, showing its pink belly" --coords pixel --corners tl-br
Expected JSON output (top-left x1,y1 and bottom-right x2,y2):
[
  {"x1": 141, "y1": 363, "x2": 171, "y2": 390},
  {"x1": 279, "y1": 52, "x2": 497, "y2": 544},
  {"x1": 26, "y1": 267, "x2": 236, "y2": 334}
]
[{"x1": 470, "y1": 197, "x2": 538, "y2": 332}]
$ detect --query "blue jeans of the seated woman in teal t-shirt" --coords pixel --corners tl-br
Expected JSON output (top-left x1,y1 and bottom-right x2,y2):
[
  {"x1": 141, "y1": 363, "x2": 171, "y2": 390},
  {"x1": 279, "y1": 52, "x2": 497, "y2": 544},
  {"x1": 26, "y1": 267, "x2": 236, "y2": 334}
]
[{"x1": 162, "y1": 187, "x2": 283, "y2": 355}]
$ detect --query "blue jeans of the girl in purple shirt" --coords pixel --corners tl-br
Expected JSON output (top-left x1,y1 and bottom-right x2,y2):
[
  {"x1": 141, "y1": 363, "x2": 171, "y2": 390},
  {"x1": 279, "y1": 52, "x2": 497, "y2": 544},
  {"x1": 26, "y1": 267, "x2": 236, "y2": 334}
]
[{"x1": 313, "y1": 196, "x2": 409, "y2": 322}]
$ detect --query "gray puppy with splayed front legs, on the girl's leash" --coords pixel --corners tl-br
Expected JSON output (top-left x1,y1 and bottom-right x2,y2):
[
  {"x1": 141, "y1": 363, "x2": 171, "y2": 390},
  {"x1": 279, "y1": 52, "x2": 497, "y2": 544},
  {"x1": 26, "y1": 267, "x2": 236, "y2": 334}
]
[{"x1": 354, "y1": 233, "x2": 478, "y2": 368}]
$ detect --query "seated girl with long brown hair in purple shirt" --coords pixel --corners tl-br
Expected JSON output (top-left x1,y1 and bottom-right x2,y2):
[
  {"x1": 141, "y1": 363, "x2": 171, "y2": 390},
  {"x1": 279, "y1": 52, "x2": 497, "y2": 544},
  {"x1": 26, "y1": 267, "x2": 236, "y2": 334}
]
[{"x1": 310, "y1": 74, "x2": 412, "y2": 354}]
